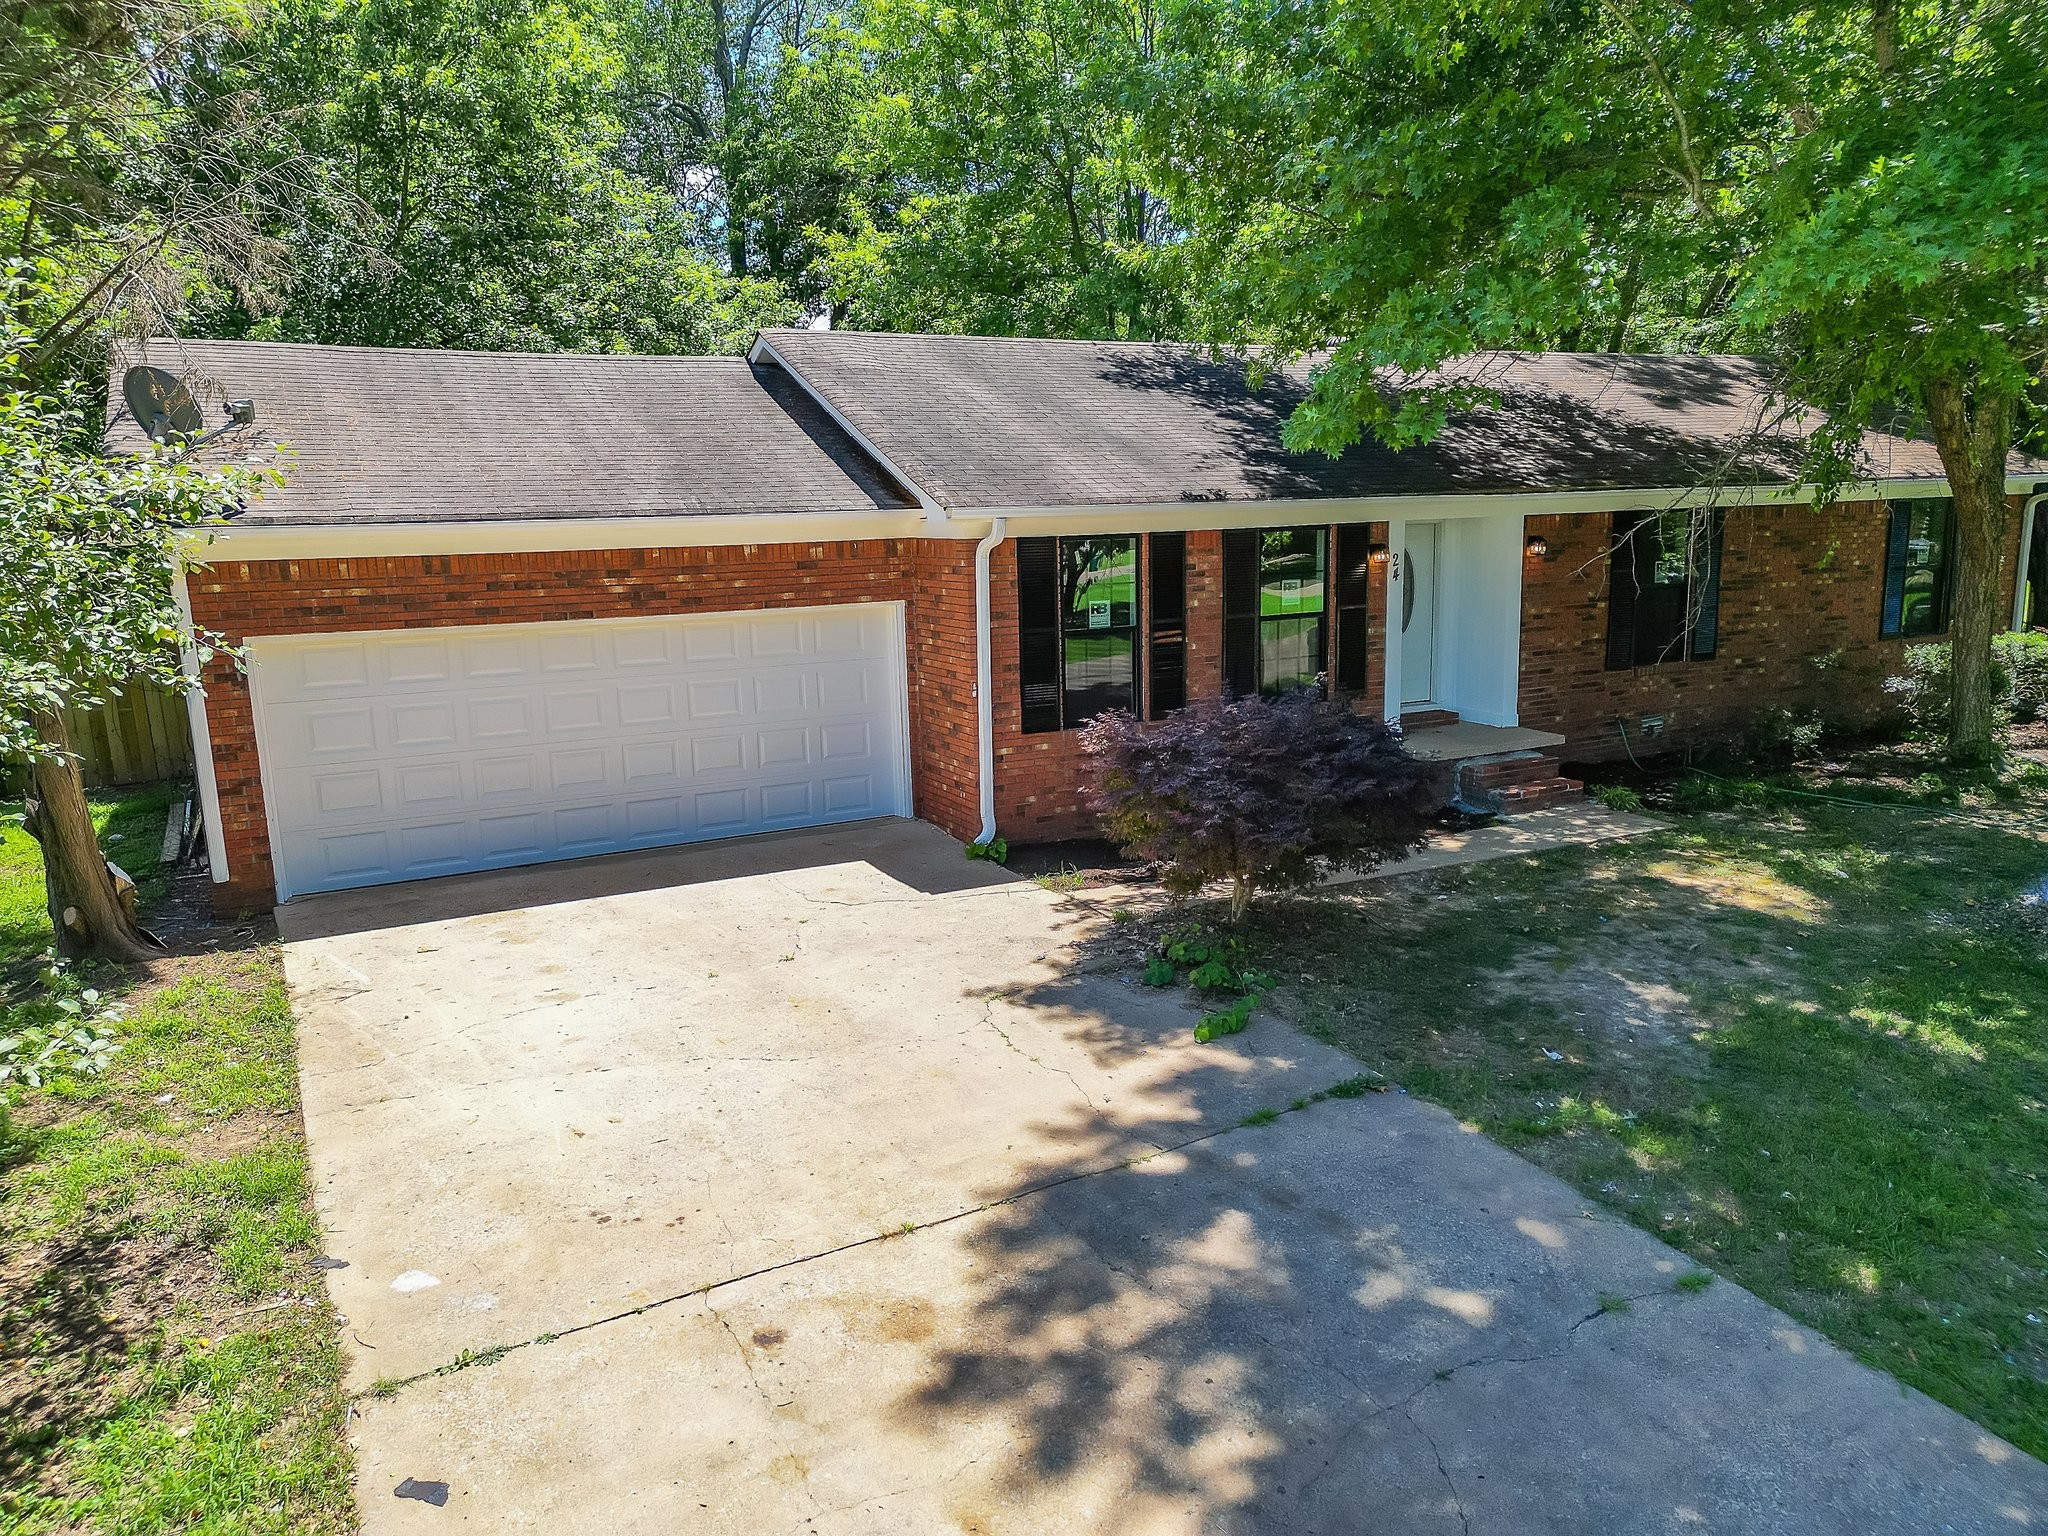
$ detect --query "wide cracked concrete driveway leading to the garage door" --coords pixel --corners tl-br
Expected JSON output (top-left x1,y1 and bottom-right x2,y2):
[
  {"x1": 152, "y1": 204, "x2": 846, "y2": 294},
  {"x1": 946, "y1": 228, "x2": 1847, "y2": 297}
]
[{"x1": 279, "y1": 821, "x2": 2048, "y2": 1536}]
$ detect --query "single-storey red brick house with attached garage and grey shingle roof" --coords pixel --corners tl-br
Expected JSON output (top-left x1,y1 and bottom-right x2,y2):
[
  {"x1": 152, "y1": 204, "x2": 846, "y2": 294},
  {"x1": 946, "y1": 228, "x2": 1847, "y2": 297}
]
[{"x1": 113, "y1": 332, "x2": 2048, "y2": 905}]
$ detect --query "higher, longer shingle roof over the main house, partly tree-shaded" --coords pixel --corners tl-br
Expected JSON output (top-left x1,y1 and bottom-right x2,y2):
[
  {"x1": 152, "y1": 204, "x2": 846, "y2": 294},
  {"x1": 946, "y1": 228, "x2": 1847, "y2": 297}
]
[{"x1": 764, "y1": 330, "x2": 1998, "y2": 508}]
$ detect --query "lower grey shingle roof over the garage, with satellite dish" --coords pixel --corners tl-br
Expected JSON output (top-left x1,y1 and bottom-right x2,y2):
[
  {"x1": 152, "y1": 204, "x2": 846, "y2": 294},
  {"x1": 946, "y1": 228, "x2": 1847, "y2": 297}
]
[{"x1": 111, "y1": 340, "x2": 913, "y2": 522}]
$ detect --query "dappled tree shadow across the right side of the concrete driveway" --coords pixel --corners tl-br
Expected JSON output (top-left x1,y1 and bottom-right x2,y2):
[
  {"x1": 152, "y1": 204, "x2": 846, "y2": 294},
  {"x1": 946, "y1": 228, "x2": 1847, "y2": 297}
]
[{"x1": 851, "y1": 876, "x2": 2048, "y2": 1532}]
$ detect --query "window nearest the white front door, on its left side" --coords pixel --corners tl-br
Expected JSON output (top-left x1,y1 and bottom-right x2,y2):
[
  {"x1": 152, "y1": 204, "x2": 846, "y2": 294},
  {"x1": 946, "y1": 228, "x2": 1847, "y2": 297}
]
[{"x1": 1223, "y1": 528, "x2": 1329, "y2": 694}]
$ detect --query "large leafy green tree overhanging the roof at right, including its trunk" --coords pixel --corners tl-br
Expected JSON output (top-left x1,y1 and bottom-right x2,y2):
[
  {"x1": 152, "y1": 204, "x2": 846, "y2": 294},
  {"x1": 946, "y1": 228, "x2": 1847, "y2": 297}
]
[{"x1": 1147, "y1": 0, "x2": 2048, "y2": 758}]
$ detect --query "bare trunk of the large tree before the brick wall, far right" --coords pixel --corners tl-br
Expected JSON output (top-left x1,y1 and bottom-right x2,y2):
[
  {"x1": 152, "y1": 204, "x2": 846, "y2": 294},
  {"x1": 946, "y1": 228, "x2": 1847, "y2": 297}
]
[{"x1": 1927, "y1": 379, "x2": 2013, "y2": 764}]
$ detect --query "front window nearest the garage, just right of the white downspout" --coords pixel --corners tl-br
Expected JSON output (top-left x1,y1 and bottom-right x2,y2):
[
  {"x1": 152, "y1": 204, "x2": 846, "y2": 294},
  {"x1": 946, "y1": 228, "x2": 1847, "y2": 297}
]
[{"x1": 1018, "y1": 535, "x2": 1139, "y2": 731}]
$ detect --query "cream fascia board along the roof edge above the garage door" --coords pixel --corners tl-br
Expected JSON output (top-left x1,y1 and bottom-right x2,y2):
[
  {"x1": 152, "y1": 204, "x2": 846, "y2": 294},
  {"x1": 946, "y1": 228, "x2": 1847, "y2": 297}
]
[{"x1": 182, "y1": 510, "x2": 928, "y2": 565}]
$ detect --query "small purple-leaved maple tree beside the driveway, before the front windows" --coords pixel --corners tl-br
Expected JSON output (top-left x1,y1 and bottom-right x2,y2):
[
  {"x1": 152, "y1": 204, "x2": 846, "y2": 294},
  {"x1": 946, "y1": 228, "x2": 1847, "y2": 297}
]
[{"x1": 1081, "y1": 692, "x2": 1444, "y2": 924}]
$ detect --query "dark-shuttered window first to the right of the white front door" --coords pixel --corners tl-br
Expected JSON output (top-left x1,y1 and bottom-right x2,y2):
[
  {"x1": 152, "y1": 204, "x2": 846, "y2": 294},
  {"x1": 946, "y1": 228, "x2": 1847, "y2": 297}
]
[{"x1": 1608, "y1": 508, "x2": 1722, "y2": 670}]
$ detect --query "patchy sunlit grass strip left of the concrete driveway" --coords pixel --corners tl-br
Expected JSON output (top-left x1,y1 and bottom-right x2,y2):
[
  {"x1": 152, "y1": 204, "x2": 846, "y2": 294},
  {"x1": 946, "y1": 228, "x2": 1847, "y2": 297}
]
[{"x1": 0, "y1": 786, "x2": 354, "y2": 1536}]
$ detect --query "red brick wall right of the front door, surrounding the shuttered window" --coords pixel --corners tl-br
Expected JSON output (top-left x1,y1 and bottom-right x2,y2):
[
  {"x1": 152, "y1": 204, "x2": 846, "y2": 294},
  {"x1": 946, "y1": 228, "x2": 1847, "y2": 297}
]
[{"x1": 1520, "y1": 502, "x2": 2017, "y2": 758}]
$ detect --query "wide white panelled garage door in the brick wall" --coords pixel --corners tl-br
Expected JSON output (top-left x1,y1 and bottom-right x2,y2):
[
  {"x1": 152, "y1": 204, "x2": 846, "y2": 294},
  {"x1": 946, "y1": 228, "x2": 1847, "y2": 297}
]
[{"x1": 250, "y1": 604, "x2": 909, "y2": 899}]
